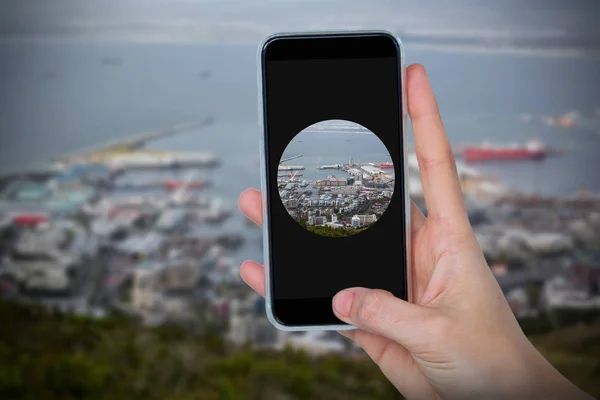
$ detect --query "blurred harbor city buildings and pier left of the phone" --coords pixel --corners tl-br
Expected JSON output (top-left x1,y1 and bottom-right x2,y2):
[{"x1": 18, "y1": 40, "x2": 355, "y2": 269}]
[{"x1": 0, "y1": 119, "x2": 251, "y2": 324}]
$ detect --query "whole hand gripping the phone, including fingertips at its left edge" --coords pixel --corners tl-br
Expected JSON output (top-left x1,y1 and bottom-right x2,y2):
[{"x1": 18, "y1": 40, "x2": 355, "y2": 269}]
[{"x1": 239, "y1": 65, "x2": 588, "y2": 399}]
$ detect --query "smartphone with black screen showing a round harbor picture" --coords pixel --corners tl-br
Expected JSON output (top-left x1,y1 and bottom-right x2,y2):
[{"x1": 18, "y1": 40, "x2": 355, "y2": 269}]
[{"x1": 257, "y1": 31, "x2": 411, "y2": 331}]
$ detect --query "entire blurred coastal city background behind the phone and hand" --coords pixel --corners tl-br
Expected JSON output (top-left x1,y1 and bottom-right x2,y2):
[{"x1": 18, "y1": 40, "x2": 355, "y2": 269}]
[{"x1": 0, "y1": 0, "x2": 600, "y2": 399}]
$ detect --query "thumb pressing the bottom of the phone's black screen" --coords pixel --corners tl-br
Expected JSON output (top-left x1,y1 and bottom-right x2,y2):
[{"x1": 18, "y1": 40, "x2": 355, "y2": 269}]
[{"x1": 333, "y1": 288, "x2": 434, "y2": 351}]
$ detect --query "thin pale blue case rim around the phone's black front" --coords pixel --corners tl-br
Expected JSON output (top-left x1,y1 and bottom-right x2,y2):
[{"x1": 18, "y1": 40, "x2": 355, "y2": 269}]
[{"x1": 256, "y1": 30, "x2": 413, "y2": 331}]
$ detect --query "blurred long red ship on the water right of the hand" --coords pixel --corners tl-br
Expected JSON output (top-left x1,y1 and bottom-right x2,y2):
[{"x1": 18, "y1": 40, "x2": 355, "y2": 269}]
[{"x1": 463, "y1": 140, "x2": 548, "y2": 162}]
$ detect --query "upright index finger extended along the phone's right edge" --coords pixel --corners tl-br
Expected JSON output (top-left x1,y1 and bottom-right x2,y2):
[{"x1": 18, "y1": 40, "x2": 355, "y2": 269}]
[{"x1": 407, "y1": 65, "x2": 466, "y2": 227}]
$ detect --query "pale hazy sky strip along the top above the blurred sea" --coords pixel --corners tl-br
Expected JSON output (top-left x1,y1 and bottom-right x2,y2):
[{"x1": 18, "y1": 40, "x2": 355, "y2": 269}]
[{"x1": 0, "y1": 0, "x2": 600, "y2": 43}]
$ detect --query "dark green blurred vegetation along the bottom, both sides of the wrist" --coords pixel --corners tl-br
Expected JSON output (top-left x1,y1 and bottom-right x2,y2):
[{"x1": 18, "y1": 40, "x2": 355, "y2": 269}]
[{"x1": 0, "y1": 301, "x2": 600, "y2": 400}]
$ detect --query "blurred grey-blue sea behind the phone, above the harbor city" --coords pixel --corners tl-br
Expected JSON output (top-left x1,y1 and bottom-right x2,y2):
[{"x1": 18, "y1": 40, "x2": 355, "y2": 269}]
[{"x1": 0, "y1": 42, "x2": 600, "y2": 264}]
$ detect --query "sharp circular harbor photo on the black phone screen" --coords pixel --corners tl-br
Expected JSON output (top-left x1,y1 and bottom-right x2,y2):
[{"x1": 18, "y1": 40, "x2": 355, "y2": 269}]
[{"x1": 277, "y1": 120, "x2": 394, "y2": 237}]
